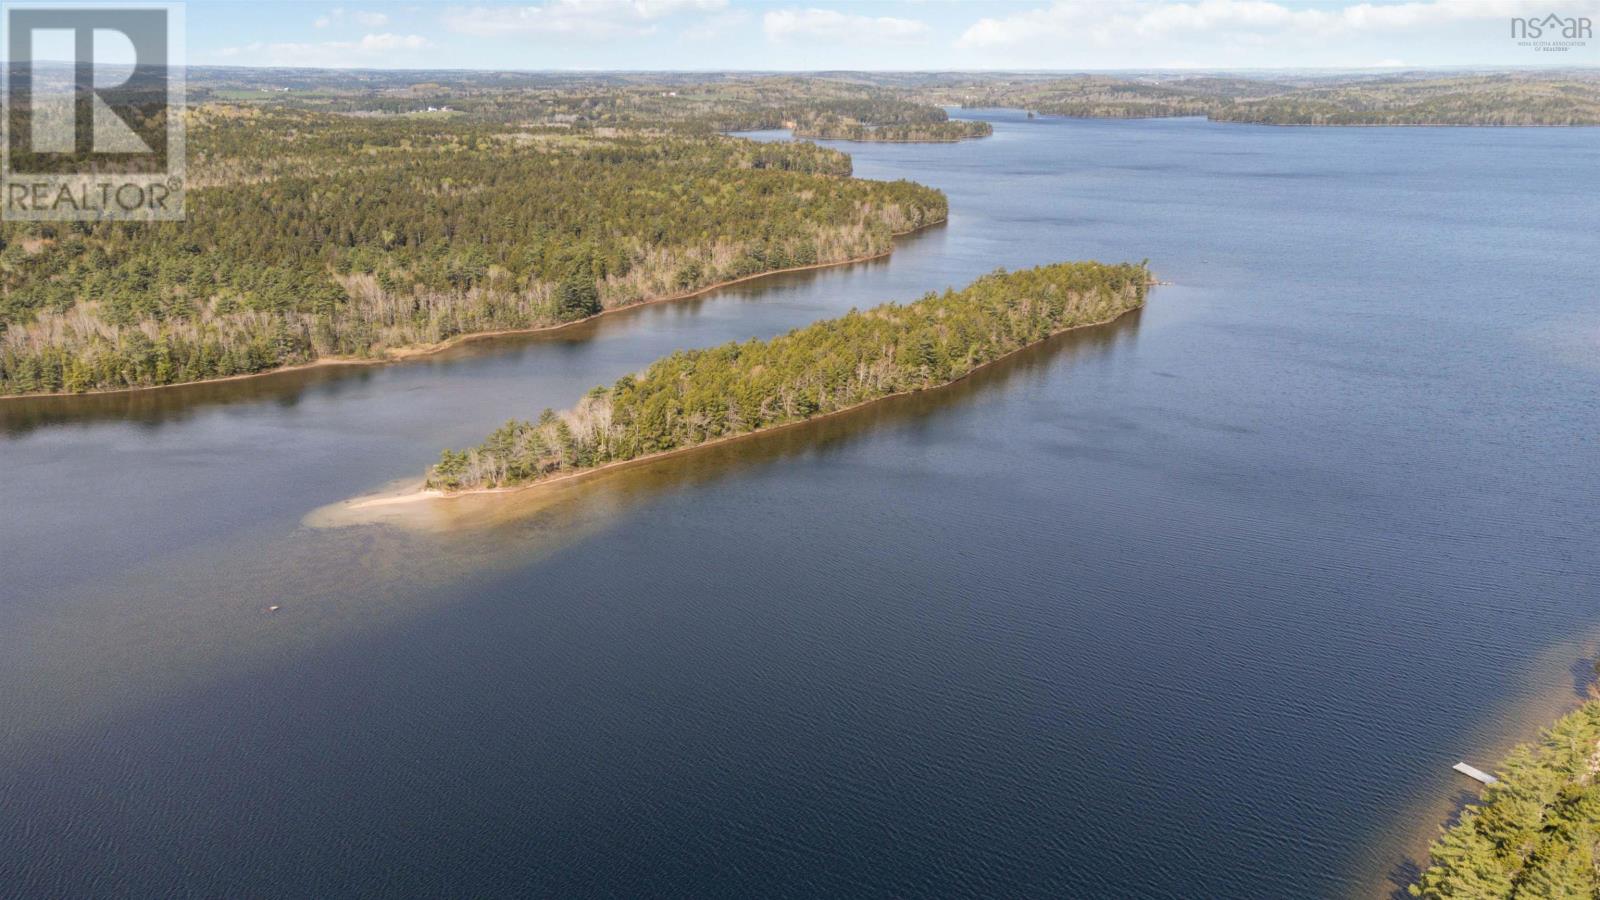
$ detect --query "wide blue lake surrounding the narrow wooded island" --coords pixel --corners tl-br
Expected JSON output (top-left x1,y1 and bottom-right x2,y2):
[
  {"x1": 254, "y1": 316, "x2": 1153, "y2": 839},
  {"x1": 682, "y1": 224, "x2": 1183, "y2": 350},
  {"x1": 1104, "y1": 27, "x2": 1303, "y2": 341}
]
[{"x1": 0, "y1": 110, "x2": 1600, "y2": 897}]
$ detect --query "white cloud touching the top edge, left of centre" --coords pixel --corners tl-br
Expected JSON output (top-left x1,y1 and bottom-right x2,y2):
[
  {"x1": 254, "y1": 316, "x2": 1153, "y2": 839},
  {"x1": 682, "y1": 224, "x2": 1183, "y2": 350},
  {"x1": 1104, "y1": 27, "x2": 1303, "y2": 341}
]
[{"x1": 443, "y1": 0, "x2": 728, "y2": 37}]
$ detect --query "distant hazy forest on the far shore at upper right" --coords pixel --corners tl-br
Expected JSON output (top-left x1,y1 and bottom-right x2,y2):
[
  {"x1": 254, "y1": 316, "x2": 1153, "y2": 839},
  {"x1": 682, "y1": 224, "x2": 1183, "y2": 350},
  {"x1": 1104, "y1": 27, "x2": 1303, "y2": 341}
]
[{"x1": 922, "y1": 72, "x2": 1600, "y2": 125}]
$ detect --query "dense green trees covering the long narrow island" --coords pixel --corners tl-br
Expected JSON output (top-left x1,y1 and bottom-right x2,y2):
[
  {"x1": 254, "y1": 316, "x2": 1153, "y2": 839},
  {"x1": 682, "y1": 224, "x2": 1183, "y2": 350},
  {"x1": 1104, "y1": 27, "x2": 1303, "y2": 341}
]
[{"x1": 427, "y1": 263, "x2": 1150, "y2": 492}]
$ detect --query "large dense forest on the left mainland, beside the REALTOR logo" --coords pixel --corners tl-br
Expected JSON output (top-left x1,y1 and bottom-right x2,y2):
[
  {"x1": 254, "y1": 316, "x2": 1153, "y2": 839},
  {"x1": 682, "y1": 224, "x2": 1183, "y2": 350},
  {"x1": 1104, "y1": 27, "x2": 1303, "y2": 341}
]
[{"x1": 0, "y1": 104, "x2": 946, "y2": 394}]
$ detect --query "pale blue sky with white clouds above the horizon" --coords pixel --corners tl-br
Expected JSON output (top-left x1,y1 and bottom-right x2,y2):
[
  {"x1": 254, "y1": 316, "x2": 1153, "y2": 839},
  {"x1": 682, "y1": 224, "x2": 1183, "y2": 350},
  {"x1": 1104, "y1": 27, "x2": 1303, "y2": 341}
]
[{"x1": 187, "y1": 0, "x2": 1600, "y2": 70}]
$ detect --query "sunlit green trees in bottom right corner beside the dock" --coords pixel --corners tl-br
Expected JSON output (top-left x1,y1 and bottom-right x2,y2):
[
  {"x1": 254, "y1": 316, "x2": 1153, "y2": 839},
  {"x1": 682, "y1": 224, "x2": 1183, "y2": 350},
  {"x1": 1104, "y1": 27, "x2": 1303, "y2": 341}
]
[{"x1": 1411, "y1": 700, "x2": 1600, "y2": 900}]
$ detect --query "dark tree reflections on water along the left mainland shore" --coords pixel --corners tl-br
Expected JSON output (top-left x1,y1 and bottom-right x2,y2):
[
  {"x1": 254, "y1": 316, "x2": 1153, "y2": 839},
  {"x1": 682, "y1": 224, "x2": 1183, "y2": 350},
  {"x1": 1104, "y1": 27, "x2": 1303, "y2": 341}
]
[{"x1": 0, "y1": 240, "x2": 915, "y2": 437}]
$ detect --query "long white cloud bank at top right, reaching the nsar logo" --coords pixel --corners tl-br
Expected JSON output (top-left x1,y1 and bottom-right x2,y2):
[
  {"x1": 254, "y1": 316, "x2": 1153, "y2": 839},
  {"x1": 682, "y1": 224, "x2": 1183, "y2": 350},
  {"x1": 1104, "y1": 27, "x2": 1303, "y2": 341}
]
[{"x1": 955, "y1": 0, "x2": 1600, "y2": 48}]
